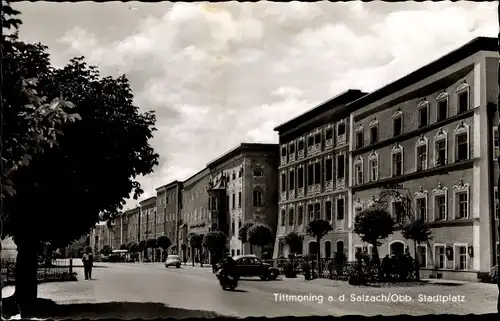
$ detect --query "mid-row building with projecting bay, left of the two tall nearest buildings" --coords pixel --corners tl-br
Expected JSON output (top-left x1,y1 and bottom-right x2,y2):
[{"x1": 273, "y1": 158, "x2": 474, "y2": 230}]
[{"x1": 207, "y1": 143, "x2": 279, "y2": 255}]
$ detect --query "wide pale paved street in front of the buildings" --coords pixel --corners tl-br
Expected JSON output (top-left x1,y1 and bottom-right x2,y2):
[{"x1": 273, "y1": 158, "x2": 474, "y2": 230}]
[{"x1": 3, "y1": 263, "x2": 497, "y2": 318}]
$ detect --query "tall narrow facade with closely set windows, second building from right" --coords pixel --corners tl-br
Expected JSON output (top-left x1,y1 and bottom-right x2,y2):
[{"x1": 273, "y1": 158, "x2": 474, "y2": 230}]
[{"x1": 274, "y1": 90, "x2": 366, "y2": 258}]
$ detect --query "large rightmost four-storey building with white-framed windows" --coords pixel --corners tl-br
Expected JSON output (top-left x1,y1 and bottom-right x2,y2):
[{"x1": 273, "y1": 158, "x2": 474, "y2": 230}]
[{"x1": 348, "y1": 38, "x2": 498, "y2": 280}]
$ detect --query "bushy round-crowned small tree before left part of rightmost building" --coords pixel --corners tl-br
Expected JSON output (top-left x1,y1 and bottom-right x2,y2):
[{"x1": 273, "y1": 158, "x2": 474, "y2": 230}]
[{"x1": 354, "y1": 203, "x2": 394, "y2": 264}]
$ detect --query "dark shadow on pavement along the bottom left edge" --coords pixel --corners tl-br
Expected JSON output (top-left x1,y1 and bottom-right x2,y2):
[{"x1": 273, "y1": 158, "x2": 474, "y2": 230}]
[{"x1": 1, "y1": 298, "x2": 222, "y2": 319}]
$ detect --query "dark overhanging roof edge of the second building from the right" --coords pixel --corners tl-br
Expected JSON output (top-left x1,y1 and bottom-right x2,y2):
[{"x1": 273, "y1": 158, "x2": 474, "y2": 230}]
[{"x1": 274, "y1": 89, "x2": 367, "y2": 132}]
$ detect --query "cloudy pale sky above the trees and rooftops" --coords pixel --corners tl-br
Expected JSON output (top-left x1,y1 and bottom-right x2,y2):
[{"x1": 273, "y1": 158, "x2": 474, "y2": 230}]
[{"x1": 13, "y1": 1, "x2": 498, "y2": 208}]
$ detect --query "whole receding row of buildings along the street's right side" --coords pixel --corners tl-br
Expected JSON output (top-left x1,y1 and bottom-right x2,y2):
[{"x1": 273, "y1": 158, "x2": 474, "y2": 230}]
[{"x1": 92, "y1": 37, "x2": 500, "y2": 280}]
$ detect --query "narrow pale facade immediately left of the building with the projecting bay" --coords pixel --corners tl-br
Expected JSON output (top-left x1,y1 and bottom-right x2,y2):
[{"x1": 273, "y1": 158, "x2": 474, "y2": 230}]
[{"x1": 177, "y1": 168, "x2": 210, "y2": 260}]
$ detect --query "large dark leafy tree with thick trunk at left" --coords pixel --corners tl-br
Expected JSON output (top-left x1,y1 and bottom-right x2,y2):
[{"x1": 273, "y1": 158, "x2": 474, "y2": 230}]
[{"x1": 1, "y1": 2, "x2": 158, "y2": 303}]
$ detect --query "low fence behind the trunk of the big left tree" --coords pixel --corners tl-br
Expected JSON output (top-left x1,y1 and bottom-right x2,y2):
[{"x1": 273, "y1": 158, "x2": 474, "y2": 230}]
[{"x1": 0, "y1": 259, "x2": 75, "y2": 285}]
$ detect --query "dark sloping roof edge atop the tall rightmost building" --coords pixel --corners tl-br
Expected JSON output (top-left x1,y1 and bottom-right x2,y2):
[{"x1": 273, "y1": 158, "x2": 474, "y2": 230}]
[{"x1": 345, "y1": 37, "x2": 498, "y2": 114}]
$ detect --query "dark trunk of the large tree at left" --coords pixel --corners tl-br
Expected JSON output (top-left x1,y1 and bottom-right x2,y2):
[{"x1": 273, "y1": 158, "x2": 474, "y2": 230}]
[{"x1": 14, "y1": 244, "x2": 38, "y2": 319}]
